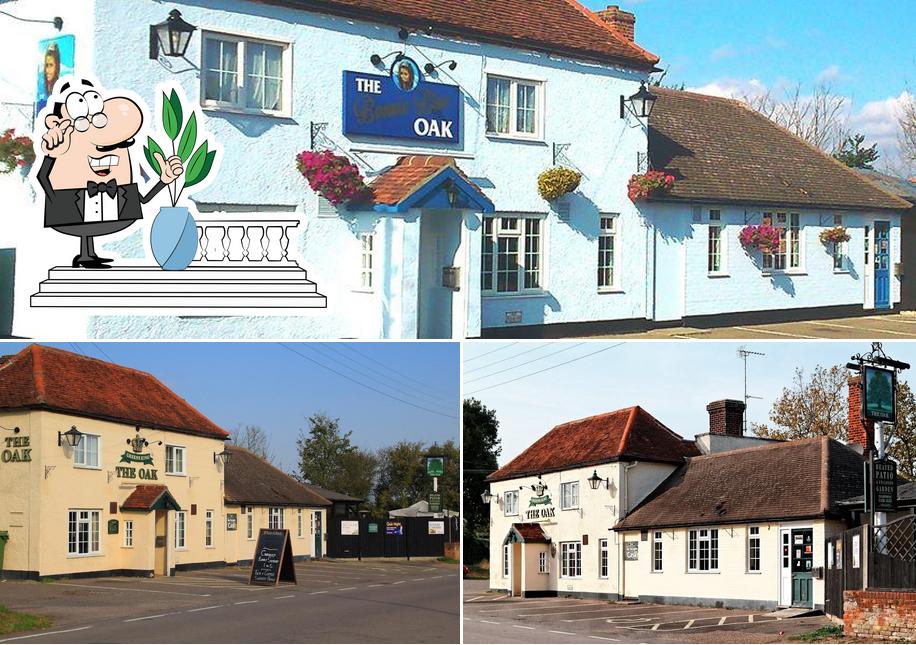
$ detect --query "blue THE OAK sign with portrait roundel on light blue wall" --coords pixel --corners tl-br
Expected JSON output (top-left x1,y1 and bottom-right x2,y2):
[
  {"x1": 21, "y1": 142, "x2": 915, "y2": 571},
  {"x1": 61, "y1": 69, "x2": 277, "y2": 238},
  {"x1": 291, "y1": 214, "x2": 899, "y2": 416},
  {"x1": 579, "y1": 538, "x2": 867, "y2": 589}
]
[{"x1": 343, "y1": 58, "x2": 462, "y2": 143}]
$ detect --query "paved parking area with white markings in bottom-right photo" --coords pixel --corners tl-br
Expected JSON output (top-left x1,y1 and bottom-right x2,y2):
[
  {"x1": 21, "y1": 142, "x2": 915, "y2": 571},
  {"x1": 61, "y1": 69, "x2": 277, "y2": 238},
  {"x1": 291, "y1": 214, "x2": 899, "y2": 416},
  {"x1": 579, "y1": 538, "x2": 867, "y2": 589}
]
[{"x1": 464, "y1": 581, "x2": 829, "y2": 643}]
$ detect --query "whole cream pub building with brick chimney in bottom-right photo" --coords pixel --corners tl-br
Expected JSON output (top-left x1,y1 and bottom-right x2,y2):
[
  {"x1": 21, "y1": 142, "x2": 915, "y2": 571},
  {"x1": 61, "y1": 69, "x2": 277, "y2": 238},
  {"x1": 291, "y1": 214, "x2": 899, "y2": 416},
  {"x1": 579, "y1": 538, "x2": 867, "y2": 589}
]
[{"x1": 489, "y1": 394, "x2": 863, "y2": 609}]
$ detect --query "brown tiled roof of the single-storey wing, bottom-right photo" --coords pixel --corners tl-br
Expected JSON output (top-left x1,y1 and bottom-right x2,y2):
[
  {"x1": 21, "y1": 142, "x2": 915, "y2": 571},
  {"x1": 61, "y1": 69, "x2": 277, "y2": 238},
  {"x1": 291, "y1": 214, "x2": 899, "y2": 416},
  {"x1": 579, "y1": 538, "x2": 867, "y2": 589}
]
[{"x1": 614, "y1": 437, "x2": 863, "y2": 531}]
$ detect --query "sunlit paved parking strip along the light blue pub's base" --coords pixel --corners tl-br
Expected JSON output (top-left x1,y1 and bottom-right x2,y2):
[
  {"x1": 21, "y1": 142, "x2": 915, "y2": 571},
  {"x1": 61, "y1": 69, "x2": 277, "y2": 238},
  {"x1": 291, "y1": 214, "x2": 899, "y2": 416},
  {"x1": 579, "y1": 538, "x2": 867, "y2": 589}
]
[{"x1": 597, "y1": 312, "x2": 916, "y2": 340}]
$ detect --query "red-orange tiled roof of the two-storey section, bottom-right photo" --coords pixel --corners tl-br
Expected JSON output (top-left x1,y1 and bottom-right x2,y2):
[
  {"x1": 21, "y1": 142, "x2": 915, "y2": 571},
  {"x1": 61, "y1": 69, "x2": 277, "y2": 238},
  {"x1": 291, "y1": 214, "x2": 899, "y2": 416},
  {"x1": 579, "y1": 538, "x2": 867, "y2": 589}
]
[{"x1": 487, "y1": 405, "x2": 698, "y2": 481}]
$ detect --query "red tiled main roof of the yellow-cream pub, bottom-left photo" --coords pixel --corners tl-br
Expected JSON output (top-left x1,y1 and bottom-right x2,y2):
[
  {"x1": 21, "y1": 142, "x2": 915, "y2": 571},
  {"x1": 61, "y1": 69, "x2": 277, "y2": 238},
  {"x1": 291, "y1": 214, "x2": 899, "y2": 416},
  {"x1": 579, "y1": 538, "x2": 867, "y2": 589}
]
[{"x1": 0, "y1": 345, "x2": 229, "y2": 439}]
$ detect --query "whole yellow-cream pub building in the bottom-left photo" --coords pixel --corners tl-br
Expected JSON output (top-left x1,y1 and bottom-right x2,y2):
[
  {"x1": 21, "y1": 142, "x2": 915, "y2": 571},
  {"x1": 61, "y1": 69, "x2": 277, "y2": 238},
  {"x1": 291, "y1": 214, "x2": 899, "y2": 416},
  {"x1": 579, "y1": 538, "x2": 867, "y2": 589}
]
[{"x1": 0, "y1": 345, "x2": 331, "y2": 579}]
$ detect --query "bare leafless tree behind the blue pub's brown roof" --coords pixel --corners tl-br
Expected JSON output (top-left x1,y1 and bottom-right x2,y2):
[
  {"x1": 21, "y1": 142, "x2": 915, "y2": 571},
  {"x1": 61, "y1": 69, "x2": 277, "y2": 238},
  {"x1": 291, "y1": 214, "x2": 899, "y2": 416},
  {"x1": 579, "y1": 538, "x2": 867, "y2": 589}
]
[{"x1": 742, "y1": 83, "x2": 847, "y2": 152}]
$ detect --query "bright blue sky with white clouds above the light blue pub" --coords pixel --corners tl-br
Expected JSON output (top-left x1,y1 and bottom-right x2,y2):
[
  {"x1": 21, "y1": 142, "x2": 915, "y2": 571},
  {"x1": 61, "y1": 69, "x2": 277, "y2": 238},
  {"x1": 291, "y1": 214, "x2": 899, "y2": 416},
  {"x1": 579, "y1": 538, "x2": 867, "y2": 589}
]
[{"x1": 584, "y1": 0, "x2": 916, "y2": 166}]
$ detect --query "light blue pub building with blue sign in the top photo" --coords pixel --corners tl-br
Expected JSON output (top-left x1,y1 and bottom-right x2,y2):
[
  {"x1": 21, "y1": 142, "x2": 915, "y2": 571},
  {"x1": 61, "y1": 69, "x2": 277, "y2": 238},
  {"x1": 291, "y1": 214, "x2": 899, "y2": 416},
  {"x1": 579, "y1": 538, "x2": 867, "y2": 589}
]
[{"x1": 0, "y1": 0, "x2": 904, "y2": 338}]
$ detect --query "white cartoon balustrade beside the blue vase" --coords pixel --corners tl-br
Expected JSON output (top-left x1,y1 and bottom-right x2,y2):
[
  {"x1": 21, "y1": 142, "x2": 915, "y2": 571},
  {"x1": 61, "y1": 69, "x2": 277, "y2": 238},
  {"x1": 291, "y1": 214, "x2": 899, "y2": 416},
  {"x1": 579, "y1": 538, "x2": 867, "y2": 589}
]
[{"x1": 194, "y1": 213, "x2": 299, "y2": 266}]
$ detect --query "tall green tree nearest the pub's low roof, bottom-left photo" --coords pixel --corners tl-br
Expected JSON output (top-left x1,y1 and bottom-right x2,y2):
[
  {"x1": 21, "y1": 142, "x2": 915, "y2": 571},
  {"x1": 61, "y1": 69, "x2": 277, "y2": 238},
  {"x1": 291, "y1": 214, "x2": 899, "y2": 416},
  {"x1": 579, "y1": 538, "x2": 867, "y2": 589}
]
[{"x1": 296, "y1": 412, "x2": 377, "y2": 499}]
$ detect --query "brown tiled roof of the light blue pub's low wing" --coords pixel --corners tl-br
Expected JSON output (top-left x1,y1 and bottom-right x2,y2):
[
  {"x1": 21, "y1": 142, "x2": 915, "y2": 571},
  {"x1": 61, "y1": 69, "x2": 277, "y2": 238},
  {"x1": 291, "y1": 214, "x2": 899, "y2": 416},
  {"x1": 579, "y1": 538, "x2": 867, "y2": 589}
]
[{"x1": 649, "y1": 87, "x2": 910, "y2": 210}]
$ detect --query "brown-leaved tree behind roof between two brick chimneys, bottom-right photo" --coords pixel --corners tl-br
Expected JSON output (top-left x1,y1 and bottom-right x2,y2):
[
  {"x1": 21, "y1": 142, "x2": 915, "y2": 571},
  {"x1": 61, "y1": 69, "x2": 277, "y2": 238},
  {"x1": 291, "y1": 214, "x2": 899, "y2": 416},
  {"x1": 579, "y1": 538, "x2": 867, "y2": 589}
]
[{"x1": 751, "y1": 365, "x2": 848, "y2": 441}]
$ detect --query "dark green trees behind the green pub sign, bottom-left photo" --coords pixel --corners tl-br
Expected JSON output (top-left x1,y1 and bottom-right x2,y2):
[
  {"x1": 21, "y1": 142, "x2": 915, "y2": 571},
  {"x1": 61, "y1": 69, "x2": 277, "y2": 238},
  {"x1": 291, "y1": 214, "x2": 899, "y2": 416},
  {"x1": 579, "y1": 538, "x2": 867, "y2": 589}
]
[{"x1": 374, "y1": 440, "x2": 460, "y2": 515}]
